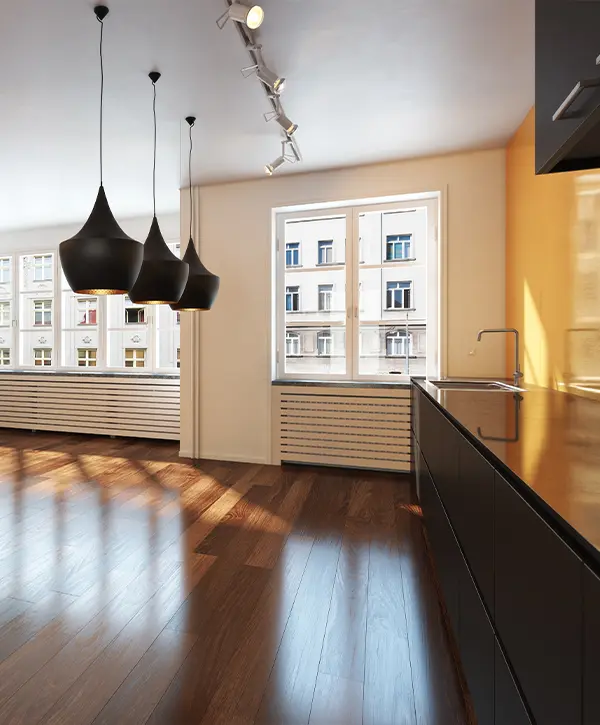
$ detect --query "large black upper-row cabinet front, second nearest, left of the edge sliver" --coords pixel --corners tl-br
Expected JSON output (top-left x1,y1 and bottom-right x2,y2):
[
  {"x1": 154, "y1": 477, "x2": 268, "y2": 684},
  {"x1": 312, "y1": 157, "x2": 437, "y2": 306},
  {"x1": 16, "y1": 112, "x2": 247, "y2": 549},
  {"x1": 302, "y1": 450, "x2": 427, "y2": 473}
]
[{"x1": 494, "y1": 474, "x2": 583, "y2": 725}]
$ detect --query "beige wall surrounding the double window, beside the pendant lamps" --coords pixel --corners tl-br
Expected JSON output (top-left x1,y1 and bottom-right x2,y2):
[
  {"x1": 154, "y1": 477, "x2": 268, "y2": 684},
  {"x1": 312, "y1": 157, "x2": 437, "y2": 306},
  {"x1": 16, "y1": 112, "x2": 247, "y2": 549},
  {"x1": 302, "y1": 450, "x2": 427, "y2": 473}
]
[{"x1": 181, "y1": 149, "x2": 505, "y2": 462}]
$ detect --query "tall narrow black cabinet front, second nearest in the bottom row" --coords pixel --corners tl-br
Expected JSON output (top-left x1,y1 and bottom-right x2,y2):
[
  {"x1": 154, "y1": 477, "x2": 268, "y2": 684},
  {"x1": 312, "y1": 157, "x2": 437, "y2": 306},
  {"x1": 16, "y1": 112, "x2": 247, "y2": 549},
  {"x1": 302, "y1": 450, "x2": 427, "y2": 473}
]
[{"x1": 458, "y1": 559, "x2": 495, "y2": 725}]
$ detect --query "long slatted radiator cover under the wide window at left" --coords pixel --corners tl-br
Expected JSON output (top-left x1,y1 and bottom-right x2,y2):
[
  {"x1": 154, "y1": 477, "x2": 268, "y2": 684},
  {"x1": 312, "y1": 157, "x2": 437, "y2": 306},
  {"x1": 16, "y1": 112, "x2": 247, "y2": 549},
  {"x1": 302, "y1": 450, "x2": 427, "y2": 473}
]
[{"x1": 0, "y1": 374, "x2": 180, "y2": 440}]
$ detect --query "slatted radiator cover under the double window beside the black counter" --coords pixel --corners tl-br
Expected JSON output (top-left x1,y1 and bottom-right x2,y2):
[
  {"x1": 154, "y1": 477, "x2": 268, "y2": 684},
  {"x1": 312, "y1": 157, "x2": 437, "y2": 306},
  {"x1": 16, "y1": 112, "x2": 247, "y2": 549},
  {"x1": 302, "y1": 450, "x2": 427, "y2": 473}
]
[{"x1": 273, "y1": 386, "x2": 411, "y2": 471}]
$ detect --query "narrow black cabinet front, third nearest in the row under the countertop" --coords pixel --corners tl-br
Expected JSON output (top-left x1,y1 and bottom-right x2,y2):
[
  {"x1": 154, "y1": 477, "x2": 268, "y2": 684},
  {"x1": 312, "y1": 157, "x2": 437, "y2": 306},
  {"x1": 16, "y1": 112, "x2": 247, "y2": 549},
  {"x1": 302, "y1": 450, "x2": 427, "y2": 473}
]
[{"x1": 449, "y1": 436, "x2": 494, "y2": 616}]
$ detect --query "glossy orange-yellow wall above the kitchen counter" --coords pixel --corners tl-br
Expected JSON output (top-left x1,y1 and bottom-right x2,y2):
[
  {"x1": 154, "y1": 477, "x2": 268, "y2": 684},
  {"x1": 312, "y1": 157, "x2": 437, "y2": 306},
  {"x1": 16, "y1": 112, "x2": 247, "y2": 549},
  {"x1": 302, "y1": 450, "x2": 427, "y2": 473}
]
[{"x1": 506, "y1": 109, "x2": 600, "y2": 389}]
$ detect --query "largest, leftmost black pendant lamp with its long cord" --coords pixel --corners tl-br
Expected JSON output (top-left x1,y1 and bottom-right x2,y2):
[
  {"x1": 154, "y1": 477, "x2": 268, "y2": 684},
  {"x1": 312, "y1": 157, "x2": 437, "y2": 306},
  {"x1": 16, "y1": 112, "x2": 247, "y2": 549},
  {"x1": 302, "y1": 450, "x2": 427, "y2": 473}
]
[{"x1": 59, "y1": 5, "x2": 144, "y2": 295}]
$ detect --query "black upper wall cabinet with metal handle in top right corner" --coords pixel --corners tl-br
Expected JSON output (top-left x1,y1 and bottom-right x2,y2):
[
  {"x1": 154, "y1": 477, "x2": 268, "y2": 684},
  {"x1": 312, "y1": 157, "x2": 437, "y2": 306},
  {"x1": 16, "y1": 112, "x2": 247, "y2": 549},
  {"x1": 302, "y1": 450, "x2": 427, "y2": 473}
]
[{"x1": 535, "y1": 0, "x2": 600, "y2": 173}]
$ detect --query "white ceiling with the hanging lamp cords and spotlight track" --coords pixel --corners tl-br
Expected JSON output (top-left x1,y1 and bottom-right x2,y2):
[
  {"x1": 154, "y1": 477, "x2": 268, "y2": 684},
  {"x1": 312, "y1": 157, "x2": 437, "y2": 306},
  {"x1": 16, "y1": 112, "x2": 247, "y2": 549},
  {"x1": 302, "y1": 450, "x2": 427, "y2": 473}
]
[{"x1": 0, "y1": 0, "x2": 534, "y2": 229}]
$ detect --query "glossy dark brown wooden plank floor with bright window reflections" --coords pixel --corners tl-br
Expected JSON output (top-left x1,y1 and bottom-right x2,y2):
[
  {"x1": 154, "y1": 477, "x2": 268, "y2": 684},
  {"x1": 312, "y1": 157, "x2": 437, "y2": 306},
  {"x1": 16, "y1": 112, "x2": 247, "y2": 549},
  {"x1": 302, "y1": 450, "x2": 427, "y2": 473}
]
[{"x1": 0, "y1": 431, "x2": 467, "y2": 725}]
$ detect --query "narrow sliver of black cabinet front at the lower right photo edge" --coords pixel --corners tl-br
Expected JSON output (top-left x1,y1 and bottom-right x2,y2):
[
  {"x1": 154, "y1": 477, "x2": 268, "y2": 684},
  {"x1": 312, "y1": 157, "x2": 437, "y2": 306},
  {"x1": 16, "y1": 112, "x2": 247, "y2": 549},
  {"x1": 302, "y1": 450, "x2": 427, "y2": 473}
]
[{"x1": 583, "y1": 567, "x2": 600, "y2": 725}]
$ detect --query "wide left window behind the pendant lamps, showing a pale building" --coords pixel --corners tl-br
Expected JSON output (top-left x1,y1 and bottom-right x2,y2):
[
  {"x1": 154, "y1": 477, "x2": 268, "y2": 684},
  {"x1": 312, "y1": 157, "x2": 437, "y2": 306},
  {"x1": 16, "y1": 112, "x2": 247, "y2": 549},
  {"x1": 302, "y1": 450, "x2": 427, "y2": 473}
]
[{"x1": 0, "y1": 250, "x2": 180, "y2": 373}]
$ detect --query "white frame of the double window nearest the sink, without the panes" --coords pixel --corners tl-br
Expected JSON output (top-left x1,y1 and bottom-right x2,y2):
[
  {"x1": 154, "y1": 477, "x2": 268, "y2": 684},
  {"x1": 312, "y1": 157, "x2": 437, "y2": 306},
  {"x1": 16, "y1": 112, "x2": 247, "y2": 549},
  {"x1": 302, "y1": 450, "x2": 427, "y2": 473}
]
[{"x1": 272, "y1": 195, "x2": 440, "y2": 383}]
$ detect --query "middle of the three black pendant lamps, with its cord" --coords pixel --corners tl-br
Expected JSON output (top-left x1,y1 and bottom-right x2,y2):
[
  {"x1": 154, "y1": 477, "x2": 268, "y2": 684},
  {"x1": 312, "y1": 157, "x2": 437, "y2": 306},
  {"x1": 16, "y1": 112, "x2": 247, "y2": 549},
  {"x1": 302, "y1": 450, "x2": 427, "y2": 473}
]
[{"x1": 129, "y1": 71, "x2": 189, "y2": 305}]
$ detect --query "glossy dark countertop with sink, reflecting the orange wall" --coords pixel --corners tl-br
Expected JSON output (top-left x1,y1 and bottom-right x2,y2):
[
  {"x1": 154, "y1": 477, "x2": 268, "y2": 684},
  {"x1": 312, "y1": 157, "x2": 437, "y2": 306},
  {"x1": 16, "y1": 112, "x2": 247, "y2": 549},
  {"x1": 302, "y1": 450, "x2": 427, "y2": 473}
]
[{"x1": 413, "y1": 379, "x2": 600, "y2": 570}]
